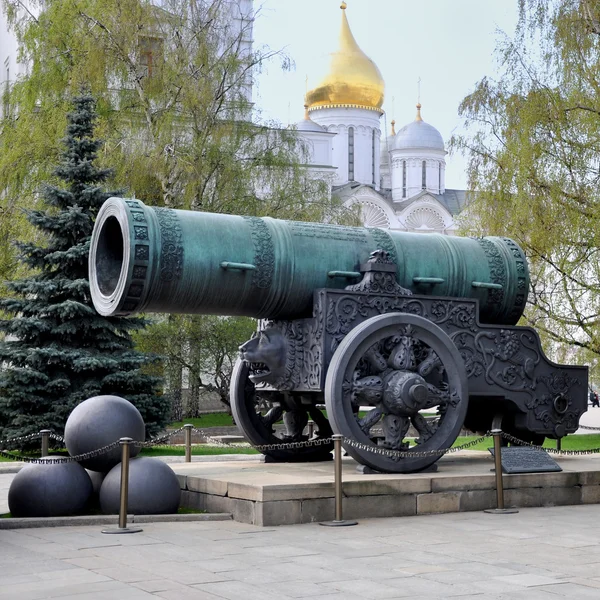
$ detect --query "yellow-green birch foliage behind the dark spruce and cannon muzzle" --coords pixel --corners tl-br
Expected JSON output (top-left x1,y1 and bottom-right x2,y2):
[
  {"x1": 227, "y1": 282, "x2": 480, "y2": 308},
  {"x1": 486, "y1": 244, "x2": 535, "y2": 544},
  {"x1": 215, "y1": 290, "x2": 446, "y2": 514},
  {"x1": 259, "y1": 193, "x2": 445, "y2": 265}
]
[{"x1": 0, "y1": 0, "x2": 356, "y2": 414}]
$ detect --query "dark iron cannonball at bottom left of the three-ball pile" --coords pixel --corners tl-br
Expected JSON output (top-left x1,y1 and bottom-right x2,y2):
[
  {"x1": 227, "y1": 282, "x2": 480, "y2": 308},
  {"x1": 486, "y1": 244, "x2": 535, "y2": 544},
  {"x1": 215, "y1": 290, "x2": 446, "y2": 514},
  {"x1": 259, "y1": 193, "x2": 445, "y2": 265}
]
[{"x1": 8, "y1": 456, "x2": 92, "y2": 517}]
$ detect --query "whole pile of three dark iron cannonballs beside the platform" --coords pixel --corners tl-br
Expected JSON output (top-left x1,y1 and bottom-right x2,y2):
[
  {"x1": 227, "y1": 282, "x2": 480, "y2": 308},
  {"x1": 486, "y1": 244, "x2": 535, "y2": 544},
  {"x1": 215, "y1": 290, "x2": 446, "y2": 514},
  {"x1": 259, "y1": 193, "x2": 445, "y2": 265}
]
[{"x1": 8, "y1": 396, "x2": 181, "y2": 517}]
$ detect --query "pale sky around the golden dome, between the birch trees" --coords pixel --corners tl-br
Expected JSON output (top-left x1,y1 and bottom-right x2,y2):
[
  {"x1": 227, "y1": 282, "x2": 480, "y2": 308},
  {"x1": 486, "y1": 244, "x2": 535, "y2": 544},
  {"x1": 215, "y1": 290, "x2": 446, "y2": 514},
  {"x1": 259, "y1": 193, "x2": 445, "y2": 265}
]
[{"x1": 254, "y1": 0, "x2": 517, "y2": 189}]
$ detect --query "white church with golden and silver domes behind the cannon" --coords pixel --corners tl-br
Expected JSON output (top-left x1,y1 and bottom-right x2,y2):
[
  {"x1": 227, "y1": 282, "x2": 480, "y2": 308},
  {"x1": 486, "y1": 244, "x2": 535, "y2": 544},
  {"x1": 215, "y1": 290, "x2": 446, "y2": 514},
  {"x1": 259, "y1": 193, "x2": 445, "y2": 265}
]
[{"x1": 296, "y1": 2, "x2": 467, "y2": 235}]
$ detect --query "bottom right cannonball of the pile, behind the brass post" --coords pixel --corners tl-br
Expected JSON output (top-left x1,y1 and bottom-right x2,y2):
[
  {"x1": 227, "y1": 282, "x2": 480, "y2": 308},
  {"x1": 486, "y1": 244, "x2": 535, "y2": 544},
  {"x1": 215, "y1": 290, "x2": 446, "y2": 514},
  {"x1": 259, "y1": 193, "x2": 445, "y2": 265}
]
[{"x1": 100, "y1": 457, "x2": 181, "y2": 515}]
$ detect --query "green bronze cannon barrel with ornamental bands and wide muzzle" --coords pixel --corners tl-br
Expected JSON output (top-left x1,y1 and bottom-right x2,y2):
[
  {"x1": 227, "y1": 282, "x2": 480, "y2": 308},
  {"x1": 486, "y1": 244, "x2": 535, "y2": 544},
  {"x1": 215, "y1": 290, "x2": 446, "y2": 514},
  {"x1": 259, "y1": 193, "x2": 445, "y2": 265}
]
[{"x1": 89, "y1": 198, "x2": 529, "y2": 325}]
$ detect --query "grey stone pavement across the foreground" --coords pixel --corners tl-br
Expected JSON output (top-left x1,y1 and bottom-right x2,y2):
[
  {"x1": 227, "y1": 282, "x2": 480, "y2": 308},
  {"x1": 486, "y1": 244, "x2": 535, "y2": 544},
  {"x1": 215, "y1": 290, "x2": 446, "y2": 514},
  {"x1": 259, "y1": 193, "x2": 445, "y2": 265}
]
[{"x1": 0, "y1": 505, "x2": 600, "y2": 600}]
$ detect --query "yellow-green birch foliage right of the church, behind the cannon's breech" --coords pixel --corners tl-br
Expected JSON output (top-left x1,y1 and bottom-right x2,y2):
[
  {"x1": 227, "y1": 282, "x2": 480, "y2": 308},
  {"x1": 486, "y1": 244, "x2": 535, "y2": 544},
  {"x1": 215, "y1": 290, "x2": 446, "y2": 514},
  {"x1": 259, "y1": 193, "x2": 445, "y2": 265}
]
[{"x1": 453, "y1": 0, "x2": 600, "y2": 364}]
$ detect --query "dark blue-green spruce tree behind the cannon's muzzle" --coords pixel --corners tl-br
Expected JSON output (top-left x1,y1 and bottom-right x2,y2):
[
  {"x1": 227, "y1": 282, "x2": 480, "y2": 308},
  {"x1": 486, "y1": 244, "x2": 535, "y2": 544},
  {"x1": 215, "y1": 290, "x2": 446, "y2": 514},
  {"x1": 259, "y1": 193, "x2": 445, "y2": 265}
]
[{"x1": 0, "y1": 91, "x2": 168, "y2": 439}]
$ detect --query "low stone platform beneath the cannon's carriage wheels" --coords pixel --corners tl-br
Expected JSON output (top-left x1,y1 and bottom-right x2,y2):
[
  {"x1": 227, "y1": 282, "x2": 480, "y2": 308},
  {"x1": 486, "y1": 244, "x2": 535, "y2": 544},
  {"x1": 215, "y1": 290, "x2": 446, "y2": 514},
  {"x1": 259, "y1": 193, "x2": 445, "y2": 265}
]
[{"x1": 171, "y1": 451, "x2": 600, "y2": 526}]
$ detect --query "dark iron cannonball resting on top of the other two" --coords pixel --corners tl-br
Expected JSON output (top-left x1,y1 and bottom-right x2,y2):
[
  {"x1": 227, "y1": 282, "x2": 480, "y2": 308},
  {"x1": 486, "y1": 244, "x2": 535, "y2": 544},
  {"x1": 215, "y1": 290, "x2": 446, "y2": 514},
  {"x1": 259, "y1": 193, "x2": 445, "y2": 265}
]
[{"x1": 65, "y1": 396, "x2": 146, "y2": 473}]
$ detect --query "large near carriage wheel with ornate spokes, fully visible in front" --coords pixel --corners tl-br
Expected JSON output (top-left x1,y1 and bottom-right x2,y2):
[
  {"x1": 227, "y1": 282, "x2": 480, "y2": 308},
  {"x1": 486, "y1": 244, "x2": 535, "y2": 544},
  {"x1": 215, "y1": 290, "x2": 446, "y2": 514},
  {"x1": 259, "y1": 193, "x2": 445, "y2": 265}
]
[{"x1": 325, "y1": 313, "x2": 468, "y2": 473}]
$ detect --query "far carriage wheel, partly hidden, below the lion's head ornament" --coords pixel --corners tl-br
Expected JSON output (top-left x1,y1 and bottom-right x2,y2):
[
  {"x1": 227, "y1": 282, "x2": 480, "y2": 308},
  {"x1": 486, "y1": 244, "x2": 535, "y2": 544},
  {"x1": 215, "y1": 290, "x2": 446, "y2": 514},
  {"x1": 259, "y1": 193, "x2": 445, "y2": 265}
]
[{"x1": 230, "y1": 359, "x2": 333, "y2": 462}]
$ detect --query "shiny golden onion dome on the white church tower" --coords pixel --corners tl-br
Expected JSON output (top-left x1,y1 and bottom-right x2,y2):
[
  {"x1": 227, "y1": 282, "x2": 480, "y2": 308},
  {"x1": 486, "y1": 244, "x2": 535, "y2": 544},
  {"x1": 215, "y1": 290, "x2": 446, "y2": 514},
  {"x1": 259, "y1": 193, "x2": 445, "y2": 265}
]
[{"x1": 306, "y1": 2, "x2": 385, "y2": 113}]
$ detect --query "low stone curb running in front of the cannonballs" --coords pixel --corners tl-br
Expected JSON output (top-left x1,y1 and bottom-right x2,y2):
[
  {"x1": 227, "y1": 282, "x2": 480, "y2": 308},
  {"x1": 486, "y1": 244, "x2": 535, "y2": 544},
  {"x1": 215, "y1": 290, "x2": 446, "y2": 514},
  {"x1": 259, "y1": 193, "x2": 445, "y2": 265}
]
[{"x1": 0, "y1": 513, "x2": 233, "y2": 529}]
